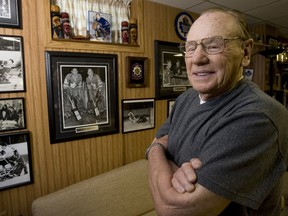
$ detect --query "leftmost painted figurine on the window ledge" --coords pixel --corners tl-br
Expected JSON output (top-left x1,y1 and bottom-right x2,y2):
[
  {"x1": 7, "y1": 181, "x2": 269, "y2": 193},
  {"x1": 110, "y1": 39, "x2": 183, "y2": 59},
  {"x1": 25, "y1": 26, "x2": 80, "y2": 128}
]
[{"x1": 50, "y1": 5, "x2": 64, "y2": 38}]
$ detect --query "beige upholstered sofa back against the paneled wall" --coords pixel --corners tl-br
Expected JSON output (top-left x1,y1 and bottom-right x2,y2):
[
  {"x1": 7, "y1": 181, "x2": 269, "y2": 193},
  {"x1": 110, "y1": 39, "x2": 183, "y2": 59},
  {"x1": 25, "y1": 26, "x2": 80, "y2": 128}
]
[{"x1": 32, "y1": 159, "x2": 156, "y2": 216}]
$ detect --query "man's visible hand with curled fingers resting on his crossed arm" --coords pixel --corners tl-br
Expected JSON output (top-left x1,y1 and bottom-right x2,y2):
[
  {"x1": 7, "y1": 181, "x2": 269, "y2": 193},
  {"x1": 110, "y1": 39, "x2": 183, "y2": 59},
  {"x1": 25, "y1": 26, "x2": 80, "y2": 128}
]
[{"x1": 171, "y1": 158, "x2": 202, "y2": 193}]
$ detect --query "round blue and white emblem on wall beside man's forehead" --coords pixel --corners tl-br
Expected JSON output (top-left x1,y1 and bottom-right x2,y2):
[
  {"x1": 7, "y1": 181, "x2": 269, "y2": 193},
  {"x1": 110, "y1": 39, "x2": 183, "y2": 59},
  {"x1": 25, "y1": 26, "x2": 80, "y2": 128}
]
[{"x1": 174, "y1": 11, "x2": 193, "y2": 41}]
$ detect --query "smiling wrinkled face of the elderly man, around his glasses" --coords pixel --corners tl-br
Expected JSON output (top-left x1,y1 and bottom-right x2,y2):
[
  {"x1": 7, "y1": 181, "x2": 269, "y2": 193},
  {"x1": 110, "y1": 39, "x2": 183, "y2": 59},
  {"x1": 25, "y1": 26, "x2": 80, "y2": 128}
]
[{"x1": 185, "y1": 12, "x2": 244, "y2": 100}]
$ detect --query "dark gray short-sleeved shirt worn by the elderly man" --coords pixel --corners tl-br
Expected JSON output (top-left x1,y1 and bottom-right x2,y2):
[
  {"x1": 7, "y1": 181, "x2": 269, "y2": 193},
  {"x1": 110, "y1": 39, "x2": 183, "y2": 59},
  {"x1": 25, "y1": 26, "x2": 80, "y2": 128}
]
[{"x1": 156, "y1": 79, "x2": 288, "y2": 216}]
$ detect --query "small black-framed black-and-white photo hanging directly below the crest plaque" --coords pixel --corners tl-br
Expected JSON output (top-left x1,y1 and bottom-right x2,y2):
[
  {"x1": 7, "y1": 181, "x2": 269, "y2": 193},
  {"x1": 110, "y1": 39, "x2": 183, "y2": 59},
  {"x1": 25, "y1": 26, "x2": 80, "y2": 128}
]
[{"x1": 122, "y1": 98, "x2": 155, "y2": 133}]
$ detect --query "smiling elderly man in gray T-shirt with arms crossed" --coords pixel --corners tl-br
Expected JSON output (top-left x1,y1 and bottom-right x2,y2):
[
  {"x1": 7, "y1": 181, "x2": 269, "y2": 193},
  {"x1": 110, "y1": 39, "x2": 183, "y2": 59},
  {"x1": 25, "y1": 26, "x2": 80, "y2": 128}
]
[{"x1": 146, "y1": 8, "x2": 288, "y2": 216}]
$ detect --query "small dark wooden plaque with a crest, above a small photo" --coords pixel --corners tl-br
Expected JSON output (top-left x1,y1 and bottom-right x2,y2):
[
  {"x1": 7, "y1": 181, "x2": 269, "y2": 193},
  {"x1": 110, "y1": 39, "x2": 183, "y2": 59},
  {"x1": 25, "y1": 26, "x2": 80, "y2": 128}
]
[{"x1": 127, "y1": 56, "x2": 149, "y2": 88}]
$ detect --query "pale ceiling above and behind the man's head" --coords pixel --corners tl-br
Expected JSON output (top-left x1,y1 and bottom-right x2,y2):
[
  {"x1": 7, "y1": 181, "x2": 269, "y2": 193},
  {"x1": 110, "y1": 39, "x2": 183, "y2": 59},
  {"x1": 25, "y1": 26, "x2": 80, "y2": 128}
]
[{"x1": 150, "y1": 0, "x2": 288, "y2": 38}]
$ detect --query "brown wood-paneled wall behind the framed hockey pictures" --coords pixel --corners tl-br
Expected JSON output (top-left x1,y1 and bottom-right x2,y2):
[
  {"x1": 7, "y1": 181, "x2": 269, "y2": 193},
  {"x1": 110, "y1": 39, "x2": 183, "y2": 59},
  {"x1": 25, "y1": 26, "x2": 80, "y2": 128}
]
[{"x1": 0, "y1": 0, "x2": 196, "y2": 216}]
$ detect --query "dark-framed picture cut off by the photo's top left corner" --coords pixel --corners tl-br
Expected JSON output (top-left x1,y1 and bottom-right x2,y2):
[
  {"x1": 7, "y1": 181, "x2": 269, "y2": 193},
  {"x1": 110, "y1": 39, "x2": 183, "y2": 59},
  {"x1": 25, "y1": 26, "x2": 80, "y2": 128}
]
[{"x1": 0, "y1": 0, "x2": 22, "y2": 29}]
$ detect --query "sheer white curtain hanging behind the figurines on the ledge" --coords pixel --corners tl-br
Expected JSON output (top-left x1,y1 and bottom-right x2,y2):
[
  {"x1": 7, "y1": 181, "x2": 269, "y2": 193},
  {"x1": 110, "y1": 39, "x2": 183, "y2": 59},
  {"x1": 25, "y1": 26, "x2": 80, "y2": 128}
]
[{"x1": 51, "y1": 0, "x2": 132, "y2": 43}]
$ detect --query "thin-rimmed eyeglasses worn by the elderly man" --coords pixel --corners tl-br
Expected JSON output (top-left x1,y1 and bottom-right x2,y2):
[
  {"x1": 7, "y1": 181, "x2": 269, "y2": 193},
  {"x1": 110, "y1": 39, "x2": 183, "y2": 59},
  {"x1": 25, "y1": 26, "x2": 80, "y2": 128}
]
[{"x1": 179, "y1": 36, "x2": 240, "y2": 58}]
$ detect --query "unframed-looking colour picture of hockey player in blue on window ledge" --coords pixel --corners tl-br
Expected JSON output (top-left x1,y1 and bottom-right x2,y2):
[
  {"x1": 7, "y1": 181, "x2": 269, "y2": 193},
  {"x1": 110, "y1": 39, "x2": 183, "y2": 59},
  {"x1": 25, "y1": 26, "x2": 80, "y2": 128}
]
[{"x1": 87, "y1": 11, "x2": 112, "y2": 42}]
